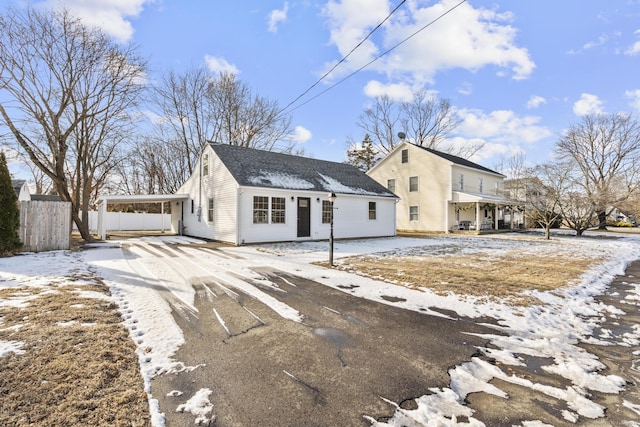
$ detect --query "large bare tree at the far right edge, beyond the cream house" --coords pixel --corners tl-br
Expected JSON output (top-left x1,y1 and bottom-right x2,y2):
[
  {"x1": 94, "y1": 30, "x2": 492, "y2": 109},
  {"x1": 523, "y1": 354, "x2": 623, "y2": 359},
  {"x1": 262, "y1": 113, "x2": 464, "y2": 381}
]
[{"x1": 556, "y1": 113, "x2": 640, "y2": 228}]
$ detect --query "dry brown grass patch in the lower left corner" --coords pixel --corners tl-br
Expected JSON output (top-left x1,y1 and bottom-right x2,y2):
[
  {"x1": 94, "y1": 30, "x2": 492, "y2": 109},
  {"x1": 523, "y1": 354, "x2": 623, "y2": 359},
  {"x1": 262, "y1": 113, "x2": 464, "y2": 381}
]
[{"x1": 0, "y1": 282, "x2": 150, "y2": 426}]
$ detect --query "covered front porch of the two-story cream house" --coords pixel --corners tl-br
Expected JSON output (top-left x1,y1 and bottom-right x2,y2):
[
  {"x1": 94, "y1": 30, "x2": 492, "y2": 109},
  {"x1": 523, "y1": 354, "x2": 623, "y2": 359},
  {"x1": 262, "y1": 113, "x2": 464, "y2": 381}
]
[{"x1": 447, "y1": 191, "x2": 521, "y2": 234}]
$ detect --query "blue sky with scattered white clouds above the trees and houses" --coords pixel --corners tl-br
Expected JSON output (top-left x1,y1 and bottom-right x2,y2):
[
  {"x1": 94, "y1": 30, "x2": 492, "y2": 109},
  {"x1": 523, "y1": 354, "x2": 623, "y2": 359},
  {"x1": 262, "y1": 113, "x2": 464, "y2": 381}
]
[{"x1": 5, "y1": 0, "x2": 640, "y2": 176}]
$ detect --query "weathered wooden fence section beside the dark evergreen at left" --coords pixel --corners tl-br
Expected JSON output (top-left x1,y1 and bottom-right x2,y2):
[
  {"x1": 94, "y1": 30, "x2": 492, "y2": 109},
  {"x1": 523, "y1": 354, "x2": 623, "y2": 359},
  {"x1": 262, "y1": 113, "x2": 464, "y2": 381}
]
[{"x1": 20, "y1": 200, "x2": 71, "y2": 252}]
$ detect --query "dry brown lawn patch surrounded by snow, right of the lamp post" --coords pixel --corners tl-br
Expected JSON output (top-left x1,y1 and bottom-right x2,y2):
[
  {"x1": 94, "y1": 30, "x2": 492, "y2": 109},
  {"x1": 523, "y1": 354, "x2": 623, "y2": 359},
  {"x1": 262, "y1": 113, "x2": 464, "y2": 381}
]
[{"x1": 337, "y1": 239, "x2": 601, "y2": 305}]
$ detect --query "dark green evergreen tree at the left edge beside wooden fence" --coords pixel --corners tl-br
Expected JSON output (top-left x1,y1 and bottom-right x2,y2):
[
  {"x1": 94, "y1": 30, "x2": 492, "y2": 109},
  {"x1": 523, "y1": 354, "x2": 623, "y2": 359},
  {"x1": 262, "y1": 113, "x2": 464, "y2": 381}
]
[{"x1": 0, "y1": 152, "x2": 21, "y2": 255}]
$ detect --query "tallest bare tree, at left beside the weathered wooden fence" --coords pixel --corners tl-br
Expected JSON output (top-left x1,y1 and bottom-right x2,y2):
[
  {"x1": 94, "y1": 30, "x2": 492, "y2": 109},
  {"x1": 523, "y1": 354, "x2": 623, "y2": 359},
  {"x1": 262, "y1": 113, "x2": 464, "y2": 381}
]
[{"x1": 0, "y1": 6, "x2": 145, "y2": 240}]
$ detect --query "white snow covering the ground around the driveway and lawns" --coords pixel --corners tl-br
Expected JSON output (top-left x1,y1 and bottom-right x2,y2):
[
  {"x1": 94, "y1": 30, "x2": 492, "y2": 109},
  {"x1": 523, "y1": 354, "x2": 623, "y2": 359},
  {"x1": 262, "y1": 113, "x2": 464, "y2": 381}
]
[{"x1": 0, "y1": 235, "x2": 640, "y2": 427}]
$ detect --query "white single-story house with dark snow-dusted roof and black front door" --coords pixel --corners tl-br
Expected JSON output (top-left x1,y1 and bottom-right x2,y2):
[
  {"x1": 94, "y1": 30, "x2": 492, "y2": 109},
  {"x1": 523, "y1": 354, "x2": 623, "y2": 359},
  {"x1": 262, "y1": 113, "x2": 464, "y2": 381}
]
[{"x1": 171, "y1": 143, "x2": 397, "y2": 245}]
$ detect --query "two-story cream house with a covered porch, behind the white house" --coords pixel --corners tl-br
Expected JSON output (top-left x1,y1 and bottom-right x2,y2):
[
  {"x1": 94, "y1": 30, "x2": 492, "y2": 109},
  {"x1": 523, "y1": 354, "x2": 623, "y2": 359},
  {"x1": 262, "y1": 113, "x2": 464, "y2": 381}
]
[{"x1": 367, "y1": 142, "x2": 514, "y2": 232}]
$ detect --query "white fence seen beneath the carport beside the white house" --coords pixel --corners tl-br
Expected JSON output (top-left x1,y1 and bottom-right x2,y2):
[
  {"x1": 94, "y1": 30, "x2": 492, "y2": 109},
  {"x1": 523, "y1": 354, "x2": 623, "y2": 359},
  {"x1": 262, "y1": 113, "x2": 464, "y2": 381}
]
[{"x1": 73, "y1": 211, "x2": 171, "y2": 233}]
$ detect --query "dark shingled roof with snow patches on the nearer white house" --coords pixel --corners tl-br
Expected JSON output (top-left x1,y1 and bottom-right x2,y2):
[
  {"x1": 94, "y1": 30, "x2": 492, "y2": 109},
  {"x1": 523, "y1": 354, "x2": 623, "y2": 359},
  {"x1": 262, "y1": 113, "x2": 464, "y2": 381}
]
[{"x1": 210, "y1": 143, "x2": 396, "y2": 197}]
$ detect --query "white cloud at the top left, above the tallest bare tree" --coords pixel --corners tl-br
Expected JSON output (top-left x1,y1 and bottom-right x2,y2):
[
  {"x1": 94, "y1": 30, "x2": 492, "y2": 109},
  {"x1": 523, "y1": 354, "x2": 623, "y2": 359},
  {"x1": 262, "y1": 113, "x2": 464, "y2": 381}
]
[{"x1": 39, "y1": 0, "x2": 155, "y2": 43}]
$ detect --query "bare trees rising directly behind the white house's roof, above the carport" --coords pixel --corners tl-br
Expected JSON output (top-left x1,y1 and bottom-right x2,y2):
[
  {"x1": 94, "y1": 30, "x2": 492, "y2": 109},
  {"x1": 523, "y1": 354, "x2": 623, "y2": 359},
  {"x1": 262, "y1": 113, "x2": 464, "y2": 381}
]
[{"x1": 141, "y1": 67, "x2": 295, "y2": 192}]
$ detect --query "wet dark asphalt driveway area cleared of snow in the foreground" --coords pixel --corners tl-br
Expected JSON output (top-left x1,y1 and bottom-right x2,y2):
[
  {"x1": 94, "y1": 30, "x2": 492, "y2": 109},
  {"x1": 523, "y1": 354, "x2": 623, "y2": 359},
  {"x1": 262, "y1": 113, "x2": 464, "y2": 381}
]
[{"x1": 152, "y1": 267, "x2": 487, "y2": 426}]
